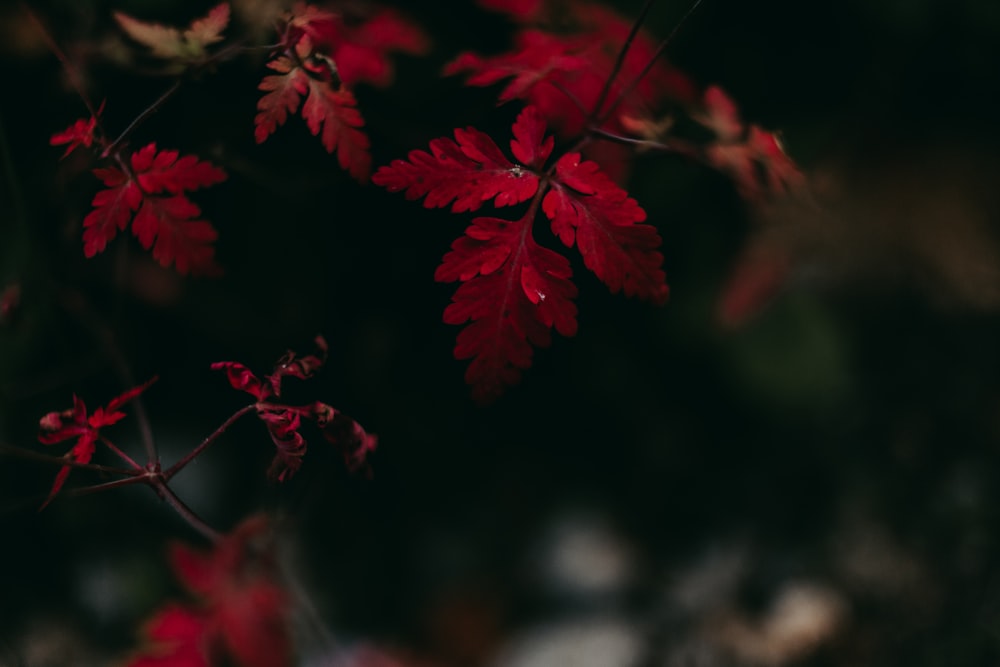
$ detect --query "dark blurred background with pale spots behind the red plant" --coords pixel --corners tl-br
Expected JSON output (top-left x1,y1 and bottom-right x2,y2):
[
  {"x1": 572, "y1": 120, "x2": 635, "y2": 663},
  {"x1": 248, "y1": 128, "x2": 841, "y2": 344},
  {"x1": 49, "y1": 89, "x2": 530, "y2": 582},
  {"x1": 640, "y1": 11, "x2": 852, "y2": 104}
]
[{"x1": 0, "y1": 0, "x2": 1000, "y2": 667}]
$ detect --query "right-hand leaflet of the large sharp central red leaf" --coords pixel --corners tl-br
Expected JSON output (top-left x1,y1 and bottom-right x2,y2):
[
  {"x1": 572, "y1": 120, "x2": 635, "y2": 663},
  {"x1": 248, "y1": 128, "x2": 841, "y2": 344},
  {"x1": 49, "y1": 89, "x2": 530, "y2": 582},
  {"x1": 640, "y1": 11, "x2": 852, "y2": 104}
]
[{"x1": 542, "y1": 153, "x2": 668, "y2": 303}]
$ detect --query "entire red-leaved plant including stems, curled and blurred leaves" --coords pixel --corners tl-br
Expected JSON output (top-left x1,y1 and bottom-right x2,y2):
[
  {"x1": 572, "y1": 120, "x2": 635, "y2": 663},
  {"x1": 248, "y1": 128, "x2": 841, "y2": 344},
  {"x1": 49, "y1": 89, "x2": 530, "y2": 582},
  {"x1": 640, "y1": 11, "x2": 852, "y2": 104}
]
[{"x1": 11, "y1": 0, "x2": 802, "y2": 667}]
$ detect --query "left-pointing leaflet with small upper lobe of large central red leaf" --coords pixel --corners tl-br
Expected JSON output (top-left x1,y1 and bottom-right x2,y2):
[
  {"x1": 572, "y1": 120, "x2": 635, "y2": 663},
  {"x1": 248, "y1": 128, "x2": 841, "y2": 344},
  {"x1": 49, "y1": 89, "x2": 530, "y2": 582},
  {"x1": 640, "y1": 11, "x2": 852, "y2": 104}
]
[{"x1": 372, "y1": 108, "x2": 552, "y2": 213}]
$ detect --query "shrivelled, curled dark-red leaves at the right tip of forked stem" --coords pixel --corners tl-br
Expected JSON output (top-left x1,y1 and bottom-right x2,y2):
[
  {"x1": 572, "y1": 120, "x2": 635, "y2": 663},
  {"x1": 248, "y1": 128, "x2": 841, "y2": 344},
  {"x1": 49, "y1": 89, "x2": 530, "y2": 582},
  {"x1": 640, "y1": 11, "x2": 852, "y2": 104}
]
[{"x1": 212, "y1": 336, "x2": 378, "y2": 482}]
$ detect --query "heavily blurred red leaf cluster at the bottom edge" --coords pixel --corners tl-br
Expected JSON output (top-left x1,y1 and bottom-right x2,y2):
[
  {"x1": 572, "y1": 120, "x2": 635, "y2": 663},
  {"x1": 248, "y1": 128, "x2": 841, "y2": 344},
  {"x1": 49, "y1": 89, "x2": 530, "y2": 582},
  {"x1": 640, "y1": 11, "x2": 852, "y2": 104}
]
[{"x1": 127, "y1": 516, "x2": 292, "y2": 667}]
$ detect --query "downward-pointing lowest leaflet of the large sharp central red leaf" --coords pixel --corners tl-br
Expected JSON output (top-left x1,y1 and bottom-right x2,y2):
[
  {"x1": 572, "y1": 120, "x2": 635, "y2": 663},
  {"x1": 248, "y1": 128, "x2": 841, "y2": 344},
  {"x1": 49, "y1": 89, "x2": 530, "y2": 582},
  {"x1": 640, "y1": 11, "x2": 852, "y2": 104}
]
[{"x1": 434, "y1": 218, "x2": 577, "y2": 402}]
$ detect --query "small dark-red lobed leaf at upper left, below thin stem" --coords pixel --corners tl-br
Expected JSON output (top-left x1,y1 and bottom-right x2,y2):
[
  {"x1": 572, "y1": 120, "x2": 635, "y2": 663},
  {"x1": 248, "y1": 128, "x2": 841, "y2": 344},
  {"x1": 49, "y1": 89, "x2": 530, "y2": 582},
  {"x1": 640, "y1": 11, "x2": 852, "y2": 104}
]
[{"x1": 83, "y1": 143, "x2": 226, "y2": 273}]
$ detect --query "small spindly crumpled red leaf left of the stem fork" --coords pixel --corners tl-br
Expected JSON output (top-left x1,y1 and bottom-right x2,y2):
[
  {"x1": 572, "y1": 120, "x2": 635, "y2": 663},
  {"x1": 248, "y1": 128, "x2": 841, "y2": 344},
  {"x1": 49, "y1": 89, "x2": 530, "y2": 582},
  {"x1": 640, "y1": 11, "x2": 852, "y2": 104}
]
[{"x1": 38, "y1": 377, "x2": 156, "y2": 508}]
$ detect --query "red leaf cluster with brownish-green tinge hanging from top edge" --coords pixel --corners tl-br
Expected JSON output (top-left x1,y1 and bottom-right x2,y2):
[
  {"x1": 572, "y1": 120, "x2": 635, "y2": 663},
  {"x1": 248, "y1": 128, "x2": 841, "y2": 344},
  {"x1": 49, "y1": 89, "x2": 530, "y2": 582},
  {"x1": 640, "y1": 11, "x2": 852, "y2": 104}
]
[{"x1": 254, "y1": 2, "x2": 427, "y2": 181}]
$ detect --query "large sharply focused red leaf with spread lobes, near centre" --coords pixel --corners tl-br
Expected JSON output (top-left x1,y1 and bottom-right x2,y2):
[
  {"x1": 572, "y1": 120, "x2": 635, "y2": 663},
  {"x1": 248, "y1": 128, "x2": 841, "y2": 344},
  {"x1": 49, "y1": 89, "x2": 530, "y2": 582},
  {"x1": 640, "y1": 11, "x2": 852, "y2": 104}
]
[{"x1": 372, "y1": 106, "x2": 667, "y2": 401}]
